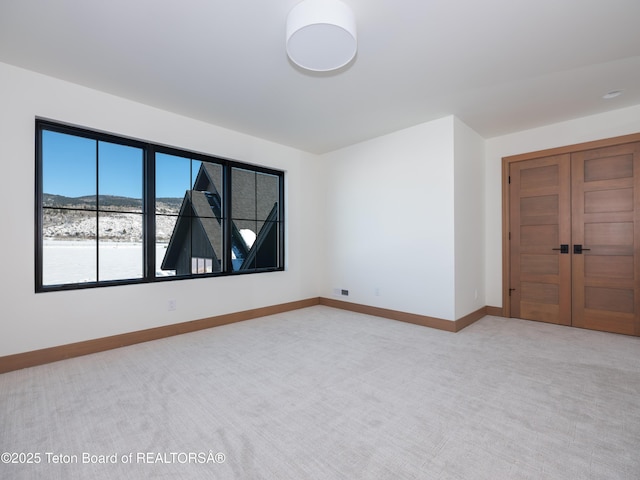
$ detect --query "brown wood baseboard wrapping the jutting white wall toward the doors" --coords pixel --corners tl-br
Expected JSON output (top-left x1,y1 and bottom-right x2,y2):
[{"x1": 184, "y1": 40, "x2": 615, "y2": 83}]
[{"x1": 320, "y1": 297, "x2": 495, "y2": 332}]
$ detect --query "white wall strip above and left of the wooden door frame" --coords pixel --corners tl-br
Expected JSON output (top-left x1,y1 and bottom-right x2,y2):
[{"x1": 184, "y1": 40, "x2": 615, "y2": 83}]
[{"x1": 485, "y1": 105, "x2": 640, "y2": 307}]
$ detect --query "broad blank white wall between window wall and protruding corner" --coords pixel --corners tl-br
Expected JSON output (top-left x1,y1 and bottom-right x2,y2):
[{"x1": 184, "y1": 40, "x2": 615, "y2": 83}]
[{"x1": 320, "y1": 117, "x2": 456, "y2": 320}]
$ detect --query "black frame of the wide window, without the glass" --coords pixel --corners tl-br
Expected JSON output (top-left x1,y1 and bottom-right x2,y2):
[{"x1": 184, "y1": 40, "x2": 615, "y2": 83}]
[{"x1": 35, "y1": 118, "x2": 285, "y2": 293}]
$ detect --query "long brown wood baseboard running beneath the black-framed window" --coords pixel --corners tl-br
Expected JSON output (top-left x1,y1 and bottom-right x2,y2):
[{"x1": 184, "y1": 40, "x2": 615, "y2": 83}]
[{"x1": 0, "y1": 297, "x2": 320, "y2": 373}]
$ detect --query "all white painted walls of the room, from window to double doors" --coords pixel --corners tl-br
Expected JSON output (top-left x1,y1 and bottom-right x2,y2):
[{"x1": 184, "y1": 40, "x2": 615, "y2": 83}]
[{"x1": 6, "y1": 59, "x2": 640, "y2": 356}]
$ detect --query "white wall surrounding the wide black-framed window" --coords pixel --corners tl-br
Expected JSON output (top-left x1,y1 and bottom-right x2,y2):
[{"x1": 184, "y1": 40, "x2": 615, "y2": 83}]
[{"x1": 0, "y1": 63, "x2": 323, "y2": 356}]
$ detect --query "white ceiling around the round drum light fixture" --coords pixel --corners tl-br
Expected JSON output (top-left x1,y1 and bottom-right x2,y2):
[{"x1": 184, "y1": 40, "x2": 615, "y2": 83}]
[{"x1": 0, "y1": 0, "x2": 640, "y2": 153}]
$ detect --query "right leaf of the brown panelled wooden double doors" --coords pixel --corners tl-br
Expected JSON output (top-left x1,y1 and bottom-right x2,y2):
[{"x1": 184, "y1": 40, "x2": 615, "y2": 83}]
[{"x1": 571, "y1": 143, "x2": 640, "y2": 335}]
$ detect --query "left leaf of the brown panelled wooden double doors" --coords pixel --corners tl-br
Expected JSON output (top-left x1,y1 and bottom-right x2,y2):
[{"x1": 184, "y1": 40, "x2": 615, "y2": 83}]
[{"x1": 509, "y1": 154, "x2": 571, "y2": 325}]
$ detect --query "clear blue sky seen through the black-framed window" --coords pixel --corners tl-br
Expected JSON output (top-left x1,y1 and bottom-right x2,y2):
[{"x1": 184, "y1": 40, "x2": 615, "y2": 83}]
[{"x1": 42, "y1": 130, "x2": 200, "y2": 198}]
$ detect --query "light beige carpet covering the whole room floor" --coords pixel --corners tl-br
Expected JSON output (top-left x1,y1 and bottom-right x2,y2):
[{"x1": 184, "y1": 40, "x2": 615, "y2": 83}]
[{"x1": 0, "y1": 306, "x2": 640, "y2": 480}]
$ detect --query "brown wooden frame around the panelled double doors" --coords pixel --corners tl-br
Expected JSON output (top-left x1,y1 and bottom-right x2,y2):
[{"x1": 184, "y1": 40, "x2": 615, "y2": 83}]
[{"x1": 502, "y1": 133, "x2": 640, "y2": 318}]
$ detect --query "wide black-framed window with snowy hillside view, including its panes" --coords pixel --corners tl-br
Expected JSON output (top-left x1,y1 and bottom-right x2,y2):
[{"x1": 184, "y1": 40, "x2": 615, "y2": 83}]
[{"x1": 36, "y1": 120, "x2": 284, "y2": 291}]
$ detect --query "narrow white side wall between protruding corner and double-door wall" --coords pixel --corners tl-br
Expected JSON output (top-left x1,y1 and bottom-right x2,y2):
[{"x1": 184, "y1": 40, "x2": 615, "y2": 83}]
[{"x1": 454, "y1": 118, "x2": 486, "y2": 319}]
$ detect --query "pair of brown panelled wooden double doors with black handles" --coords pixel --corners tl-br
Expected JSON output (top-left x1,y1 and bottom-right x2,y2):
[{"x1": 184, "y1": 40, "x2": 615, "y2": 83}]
[{"x1": 508, "y1": 142, "x2": 640, "y2": 335}]
